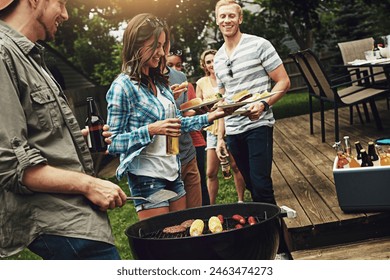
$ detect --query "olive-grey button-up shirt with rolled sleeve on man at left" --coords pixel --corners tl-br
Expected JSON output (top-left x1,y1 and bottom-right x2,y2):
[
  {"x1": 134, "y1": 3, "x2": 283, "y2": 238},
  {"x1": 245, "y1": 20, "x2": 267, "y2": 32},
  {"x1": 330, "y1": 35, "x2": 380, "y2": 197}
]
[{"x1": 0, "y1": 20, "x2": 114, "y2": 257}]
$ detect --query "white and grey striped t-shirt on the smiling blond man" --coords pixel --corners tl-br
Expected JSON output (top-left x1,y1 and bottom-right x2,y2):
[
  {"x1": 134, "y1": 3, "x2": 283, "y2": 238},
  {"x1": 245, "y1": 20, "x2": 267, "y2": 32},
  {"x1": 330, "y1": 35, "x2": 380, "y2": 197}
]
[{"x1": 214, "y1": 34, "x2": 283, "y2": 135}]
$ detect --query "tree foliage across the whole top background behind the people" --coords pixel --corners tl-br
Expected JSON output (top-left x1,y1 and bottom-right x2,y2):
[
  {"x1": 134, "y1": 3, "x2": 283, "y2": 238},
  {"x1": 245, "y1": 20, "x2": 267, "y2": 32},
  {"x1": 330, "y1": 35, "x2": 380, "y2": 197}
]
[{"x1": 53, "y1": 0, "x2": 390, "y2": 84}]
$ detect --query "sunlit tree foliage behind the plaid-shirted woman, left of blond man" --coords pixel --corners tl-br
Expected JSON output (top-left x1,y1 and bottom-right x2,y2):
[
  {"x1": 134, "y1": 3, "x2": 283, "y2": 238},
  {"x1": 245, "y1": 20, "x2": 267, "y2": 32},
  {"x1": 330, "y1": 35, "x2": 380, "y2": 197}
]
[{"x1": 53, "y1": 0, "x2": 216, "y2": 84}]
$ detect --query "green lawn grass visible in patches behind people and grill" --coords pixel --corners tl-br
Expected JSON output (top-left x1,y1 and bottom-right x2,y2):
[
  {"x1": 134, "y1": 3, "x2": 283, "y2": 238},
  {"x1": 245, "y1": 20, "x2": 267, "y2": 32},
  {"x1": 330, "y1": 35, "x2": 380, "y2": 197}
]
[{"x1": 6, "y1": 89, "x2": 329, "y2": 260}]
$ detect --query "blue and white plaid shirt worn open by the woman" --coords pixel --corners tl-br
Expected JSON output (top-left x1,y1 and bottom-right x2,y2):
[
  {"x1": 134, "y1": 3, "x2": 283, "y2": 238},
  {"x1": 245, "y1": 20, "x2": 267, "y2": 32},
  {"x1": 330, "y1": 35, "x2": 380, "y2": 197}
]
[{"x1": 106, "y1": 73, "x2": 209, "y2": 179}]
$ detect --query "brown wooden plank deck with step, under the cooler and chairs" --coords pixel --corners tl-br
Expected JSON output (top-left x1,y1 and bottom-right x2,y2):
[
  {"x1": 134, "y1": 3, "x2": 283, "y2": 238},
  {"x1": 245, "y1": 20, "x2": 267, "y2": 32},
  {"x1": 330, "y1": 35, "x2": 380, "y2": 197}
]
[{"x1": 272, "y1": 97, "x2": 390, "y2": 259}]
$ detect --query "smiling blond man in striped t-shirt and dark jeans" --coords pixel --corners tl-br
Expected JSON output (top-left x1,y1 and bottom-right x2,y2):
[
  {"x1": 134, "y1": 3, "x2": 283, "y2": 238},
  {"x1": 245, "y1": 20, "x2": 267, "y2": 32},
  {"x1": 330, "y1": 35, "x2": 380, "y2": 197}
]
[{"x1": 214, "y1": 0, "x2": 290, "y2": 204}]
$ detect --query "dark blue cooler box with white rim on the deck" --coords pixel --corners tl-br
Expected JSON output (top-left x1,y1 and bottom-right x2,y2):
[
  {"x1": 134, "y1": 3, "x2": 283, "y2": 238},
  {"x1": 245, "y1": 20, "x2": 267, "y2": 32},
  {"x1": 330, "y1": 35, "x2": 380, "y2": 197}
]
[{"x1": 333, "y1": 157, "x2": 390, "y2": 212}]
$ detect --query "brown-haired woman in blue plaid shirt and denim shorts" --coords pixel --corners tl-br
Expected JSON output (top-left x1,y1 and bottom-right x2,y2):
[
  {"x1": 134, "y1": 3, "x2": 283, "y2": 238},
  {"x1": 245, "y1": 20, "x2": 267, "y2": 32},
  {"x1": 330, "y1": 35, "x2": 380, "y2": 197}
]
[{"x1": 107, "y1": 14, "x2": 225, "y2": 219}]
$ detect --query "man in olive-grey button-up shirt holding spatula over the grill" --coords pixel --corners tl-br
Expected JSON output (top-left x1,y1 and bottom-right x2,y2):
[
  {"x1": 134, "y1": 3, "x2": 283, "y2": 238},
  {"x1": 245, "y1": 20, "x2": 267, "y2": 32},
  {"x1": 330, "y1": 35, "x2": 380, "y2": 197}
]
[{"x1": 0, "y1": 0, "x2": 126, "y2": 259}]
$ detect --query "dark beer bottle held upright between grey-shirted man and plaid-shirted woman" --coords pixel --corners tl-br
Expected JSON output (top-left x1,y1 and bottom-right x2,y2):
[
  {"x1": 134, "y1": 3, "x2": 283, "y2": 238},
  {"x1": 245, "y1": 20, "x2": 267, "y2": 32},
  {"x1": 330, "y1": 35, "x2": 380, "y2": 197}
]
[{"x1": 85, "y1": 97, "x2": 107, "y2": 153}]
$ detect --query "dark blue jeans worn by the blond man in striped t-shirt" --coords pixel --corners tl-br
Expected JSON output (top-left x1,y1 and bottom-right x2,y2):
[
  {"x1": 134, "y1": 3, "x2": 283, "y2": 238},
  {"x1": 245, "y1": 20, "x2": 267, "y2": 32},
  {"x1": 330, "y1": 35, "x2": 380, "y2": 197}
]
[{"x1": 226, "y1": 126, "x2": 276, "y2": 204}]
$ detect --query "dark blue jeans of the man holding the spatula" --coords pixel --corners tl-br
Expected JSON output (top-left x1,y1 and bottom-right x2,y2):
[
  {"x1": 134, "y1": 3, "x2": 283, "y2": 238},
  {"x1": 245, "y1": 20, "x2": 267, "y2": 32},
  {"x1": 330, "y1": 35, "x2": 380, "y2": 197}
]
[{"x1": 28, "y1": 234, "x2": 120, "y2": 260}]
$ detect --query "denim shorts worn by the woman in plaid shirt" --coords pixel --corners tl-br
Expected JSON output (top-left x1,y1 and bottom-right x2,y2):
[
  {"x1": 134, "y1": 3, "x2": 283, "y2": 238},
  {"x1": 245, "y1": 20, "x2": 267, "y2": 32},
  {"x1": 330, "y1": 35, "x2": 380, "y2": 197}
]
[{"x1": 127, "y1": 173, "x2": 186, "y2": 212}]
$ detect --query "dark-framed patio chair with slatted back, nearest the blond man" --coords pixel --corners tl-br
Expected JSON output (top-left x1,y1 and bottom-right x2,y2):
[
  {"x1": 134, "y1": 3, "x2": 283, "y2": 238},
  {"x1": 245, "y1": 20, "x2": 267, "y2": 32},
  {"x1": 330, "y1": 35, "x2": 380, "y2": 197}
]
[{"x1": 291, "y1": 49, "x2": 388, "y2": 142}]
